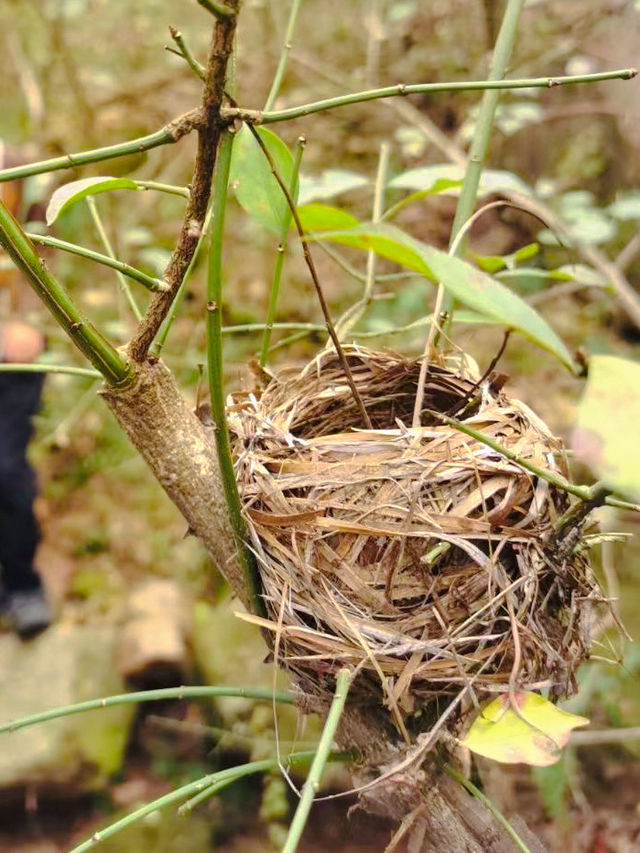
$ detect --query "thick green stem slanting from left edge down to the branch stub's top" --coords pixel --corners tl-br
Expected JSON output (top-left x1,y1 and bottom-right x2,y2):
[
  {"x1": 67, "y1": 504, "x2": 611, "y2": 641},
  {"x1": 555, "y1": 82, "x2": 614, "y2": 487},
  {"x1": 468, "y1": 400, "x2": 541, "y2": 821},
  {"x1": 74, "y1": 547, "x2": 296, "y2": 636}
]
[{"x1": 0, "y1": 201, "x2": 134, "y2": 386}]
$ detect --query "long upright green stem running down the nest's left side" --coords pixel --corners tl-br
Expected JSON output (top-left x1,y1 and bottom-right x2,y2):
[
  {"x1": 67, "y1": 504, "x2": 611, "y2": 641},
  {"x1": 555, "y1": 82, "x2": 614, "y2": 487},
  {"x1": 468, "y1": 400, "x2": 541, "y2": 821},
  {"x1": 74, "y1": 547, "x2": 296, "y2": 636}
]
[{"x1": 207, "y1": 130, "x2": 264, "y2": 614}]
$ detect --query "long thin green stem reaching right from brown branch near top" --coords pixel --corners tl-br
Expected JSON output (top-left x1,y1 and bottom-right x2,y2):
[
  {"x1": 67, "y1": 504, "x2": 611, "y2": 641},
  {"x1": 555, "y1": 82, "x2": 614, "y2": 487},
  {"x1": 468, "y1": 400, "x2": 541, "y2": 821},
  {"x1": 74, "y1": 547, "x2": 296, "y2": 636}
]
[{"x1": 222, "y1": 68, "x2": 637, "y2": 124}]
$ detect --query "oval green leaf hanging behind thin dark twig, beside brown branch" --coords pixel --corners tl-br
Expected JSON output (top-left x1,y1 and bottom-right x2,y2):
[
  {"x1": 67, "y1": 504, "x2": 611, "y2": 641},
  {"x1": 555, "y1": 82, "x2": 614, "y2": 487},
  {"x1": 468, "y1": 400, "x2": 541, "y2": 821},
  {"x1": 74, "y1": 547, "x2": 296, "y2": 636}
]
[{"x1": 229, "y1": 126, "x2": 295, "y2": 234}]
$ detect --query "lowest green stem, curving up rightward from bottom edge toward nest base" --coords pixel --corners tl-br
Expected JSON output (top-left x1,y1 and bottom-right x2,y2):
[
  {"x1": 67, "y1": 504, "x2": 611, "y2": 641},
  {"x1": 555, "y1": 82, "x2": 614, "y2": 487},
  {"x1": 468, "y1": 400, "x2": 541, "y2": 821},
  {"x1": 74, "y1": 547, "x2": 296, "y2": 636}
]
[{"x1": 70, "y1": 752, "x2": 313, "y2": 853}]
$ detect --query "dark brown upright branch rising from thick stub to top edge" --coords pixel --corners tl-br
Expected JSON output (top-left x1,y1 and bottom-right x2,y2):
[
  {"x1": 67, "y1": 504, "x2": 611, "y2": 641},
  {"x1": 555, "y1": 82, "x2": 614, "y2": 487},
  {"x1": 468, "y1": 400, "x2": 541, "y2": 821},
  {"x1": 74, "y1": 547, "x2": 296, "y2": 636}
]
[{"x1": 129, "y1": 0, "x2": 238, "y2": 362}]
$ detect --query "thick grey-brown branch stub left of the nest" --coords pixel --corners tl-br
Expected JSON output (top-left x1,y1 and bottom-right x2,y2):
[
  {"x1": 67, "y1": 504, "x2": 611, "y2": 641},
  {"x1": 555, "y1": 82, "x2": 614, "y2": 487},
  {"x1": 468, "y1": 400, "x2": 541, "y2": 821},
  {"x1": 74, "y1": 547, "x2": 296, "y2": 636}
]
[{"x1": 102, "y1": 362, "x2": 251, "y2": 608}]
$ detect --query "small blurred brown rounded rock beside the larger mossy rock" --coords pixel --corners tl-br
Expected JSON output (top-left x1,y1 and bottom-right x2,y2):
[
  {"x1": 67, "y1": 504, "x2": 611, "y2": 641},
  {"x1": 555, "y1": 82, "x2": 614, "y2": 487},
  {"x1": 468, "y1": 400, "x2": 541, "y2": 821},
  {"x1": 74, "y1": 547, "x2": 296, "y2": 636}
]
[{"x1": 117, "y1": 580, "x2": 189, "y2": 689}]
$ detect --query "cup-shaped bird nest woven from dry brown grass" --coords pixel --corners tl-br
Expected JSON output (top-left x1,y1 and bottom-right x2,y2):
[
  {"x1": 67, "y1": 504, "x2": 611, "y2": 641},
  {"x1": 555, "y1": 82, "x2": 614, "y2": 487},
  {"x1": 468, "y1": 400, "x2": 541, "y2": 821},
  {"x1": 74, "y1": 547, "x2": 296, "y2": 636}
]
[{"x1": 230, "y1": 346, "x2": 597, "y2": 720}]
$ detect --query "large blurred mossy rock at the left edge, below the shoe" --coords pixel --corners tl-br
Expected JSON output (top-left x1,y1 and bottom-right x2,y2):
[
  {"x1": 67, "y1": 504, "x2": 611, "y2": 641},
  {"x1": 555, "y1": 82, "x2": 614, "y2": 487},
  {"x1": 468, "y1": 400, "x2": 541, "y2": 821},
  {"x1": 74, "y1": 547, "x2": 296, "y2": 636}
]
[{"x1": 0, "y1": 622, "x2": 134, "y2": 796}]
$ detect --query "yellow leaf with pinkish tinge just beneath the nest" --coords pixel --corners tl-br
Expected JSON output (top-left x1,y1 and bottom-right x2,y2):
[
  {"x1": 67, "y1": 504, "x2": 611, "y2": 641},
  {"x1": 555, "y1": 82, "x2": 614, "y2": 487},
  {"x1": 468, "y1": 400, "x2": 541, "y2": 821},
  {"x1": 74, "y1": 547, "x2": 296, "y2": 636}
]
[{"x1": 462, "y1": 692, "x2": 589, "y2": 767}]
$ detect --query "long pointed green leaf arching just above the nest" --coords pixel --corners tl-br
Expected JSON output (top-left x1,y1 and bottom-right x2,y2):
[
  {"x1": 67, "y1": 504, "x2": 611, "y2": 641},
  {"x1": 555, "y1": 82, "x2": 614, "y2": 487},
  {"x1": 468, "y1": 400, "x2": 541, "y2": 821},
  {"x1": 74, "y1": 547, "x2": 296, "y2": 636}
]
[{"x1": 308, "y1": 223, "x2": 574, "y2": 370}]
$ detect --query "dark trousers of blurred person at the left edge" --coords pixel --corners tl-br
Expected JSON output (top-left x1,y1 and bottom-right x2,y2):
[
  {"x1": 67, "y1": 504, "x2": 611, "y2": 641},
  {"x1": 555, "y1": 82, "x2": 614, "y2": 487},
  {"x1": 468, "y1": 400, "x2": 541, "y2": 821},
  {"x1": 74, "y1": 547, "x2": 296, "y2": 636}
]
[{"x1": 0, "y1": 373, "x2": 43, "y2": 592}]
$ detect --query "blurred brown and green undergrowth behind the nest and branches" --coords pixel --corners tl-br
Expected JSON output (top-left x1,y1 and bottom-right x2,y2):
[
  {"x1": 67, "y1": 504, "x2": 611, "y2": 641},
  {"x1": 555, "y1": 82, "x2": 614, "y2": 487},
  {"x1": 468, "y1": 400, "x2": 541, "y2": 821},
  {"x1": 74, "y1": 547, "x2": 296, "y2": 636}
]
[{"x1": 0, "y1": 0, "x2": 640, "y2": 853}]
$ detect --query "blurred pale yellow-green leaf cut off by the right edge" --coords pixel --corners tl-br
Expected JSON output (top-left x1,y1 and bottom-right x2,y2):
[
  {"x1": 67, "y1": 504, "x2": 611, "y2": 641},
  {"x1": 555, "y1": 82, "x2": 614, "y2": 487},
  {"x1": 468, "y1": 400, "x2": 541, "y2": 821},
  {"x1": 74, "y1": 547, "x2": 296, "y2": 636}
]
[{"x1": 572, "y1": 355, "x2": 640, "y2": 501}]
